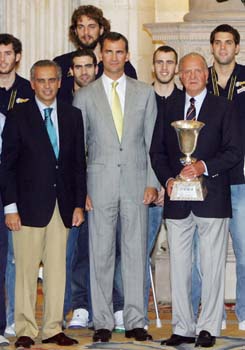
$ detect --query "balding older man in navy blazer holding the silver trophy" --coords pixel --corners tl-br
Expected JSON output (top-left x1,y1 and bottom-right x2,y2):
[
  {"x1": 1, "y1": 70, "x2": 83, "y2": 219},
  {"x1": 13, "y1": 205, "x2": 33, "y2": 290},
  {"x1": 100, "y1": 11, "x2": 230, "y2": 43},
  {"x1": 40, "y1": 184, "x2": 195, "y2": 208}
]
[{"x1": 150, "y1": 53, "x2": 241, "y2": 347}]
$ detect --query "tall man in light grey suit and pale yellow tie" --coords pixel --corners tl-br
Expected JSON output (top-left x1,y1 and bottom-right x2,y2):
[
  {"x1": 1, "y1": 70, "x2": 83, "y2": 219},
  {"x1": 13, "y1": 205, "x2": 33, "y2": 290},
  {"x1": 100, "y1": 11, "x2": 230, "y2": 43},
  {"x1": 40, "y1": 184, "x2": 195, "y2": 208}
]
[{"x1": 74, "y1": 32, "x2": 158, "y2": 342}]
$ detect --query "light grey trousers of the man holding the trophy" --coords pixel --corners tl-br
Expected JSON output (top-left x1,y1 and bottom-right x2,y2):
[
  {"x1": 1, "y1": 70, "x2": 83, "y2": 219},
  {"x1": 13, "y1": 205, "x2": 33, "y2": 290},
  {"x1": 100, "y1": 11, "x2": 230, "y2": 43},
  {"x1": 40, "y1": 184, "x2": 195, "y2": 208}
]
[{"x1": 166, "y1": 213, "x2": 229, "y2": 337}]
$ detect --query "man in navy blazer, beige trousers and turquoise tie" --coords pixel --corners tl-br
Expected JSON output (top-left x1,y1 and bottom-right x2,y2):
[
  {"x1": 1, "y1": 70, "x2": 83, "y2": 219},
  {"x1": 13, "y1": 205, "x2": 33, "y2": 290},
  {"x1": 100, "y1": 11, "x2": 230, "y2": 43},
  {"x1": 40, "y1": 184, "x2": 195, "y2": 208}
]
[{"x1": 1, "y1": 60, "x2": 86, "y2": 348}]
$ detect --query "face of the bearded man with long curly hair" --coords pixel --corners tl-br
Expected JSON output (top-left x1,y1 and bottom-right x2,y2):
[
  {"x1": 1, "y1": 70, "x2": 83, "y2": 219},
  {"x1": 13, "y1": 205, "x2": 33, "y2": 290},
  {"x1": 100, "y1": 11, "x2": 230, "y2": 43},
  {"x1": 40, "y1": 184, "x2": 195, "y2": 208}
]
[{"x1": 75, "y1": 16, "x2": 104, "y2": 50}]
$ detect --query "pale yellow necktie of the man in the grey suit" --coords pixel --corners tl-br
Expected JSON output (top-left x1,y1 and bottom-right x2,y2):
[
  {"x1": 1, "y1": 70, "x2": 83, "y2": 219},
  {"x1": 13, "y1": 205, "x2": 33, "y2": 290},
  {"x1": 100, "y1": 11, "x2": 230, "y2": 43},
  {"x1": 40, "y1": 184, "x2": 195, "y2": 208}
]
[{"x1": 111, "y1": 81, "x2": 123, "y2": 142}]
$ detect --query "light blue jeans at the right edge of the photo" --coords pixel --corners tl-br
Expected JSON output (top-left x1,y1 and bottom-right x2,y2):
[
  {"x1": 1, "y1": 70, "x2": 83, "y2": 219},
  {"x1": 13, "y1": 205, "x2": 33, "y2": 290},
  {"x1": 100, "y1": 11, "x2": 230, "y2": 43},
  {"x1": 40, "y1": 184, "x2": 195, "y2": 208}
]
[{"x1": 230, "y1": 184, "x2": 245, "y2": 322}]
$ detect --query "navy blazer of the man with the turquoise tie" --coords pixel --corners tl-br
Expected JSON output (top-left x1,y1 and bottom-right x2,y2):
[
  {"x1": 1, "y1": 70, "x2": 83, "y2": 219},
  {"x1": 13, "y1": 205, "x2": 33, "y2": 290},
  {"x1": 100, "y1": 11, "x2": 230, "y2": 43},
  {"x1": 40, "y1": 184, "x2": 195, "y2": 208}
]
[{"x1": 0, "y1": 99, "x2": 86, "y2": 227}]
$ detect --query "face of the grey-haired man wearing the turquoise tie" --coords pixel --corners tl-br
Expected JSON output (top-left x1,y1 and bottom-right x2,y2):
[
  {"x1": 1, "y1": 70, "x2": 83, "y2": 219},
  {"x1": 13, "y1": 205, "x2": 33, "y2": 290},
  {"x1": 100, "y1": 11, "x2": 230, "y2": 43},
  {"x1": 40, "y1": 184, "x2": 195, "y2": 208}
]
[{"x1": 31, "y1": 66, "x2": 60, "y2": 106}]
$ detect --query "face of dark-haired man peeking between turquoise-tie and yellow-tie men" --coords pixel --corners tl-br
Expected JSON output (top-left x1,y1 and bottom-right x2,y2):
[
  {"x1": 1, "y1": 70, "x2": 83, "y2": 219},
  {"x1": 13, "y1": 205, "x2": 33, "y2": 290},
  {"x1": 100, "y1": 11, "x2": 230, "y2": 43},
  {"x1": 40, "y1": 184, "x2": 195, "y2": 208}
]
[{"x1": 71, "y1": 56, "x2": 98, "y2": 87}]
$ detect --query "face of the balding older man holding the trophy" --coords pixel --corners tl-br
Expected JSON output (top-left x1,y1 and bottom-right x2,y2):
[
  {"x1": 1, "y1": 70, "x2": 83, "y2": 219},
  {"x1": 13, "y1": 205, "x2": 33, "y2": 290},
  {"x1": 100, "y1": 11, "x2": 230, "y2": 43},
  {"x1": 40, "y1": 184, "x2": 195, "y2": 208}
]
[{"x1": 179, "y1": 56, "x2": 208, "y2": 97}]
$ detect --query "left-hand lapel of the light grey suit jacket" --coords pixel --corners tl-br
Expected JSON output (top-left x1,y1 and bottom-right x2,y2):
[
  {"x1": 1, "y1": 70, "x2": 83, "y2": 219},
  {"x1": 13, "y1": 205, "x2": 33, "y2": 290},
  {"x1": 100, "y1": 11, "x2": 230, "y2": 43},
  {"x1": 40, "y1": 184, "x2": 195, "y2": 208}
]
[{"x1": 92, "y1": 78, "x2": 119, "y2": 142}]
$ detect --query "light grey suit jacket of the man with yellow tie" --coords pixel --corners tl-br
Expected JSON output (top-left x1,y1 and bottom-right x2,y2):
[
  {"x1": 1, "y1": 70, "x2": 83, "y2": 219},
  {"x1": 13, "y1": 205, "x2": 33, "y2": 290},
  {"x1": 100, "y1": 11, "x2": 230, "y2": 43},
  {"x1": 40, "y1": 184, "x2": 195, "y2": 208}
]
[{"x1": 73, "y1": 77, "x2": 158, "y2": 204}]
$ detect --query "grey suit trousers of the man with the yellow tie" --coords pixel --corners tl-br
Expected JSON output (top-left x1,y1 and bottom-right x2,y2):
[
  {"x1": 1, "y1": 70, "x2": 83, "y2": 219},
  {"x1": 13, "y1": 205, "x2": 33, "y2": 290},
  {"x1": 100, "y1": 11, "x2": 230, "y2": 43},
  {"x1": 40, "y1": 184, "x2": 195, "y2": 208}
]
[{"x1": 89, "y1": 190, "x2": 148, "y2": 330}]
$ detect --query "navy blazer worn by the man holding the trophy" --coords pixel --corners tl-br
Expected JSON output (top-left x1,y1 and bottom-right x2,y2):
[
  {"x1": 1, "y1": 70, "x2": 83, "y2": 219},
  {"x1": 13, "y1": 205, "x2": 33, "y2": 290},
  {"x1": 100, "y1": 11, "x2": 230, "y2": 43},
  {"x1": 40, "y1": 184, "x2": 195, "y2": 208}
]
[{"x1": 150, "y1": 93, "x2": 242, "y2": 219}]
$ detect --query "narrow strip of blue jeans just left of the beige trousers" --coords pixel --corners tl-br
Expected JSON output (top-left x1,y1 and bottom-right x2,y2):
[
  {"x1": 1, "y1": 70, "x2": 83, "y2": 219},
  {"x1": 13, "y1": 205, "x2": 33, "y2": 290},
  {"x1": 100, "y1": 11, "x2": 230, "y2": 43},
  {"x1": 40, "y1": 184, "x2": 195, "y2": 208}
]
[{"x1": 5, "y1": 230, "x2": 15, "y2": 326}]
